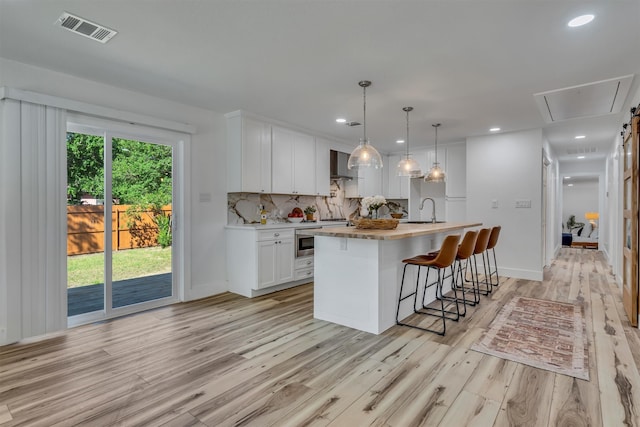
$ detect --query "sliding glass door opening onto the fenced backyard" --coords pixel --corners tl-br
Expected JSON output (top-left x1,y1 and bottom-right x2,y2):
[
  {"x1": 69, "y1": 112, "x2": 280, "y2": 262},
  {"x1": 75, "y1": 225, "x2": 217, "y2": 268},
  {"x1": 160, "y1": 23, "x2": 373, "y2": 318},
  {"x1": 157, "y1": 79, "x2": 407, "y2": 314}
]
[{"x1": 67, "y1": 120, "x2": 179, "y2": 324}]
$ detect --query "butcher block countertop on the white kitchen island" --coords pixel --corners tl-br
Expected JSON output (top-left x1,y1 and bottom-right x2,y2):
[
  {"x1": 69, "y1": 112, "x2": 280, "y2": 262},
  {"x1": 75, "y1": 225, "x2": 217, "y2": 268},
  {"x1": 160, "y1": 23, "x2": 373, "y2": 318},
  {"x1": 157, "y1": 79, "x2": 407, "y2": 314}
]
[{"x1": 305, "y1": 222, "x2": 482, "y2": 240}]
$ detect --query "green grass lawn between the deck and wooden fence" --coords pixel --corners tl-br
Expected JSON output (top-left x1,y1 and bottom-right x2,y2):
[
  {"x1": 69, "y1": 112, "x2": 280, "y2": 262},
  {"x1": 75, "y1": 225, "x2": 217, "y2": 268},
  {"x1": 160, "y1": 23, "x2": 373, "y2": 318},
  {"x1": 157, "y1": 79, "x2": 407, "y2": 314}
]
[{"x1": 67, "y1": 246, "x2": 171, "y2": 288}]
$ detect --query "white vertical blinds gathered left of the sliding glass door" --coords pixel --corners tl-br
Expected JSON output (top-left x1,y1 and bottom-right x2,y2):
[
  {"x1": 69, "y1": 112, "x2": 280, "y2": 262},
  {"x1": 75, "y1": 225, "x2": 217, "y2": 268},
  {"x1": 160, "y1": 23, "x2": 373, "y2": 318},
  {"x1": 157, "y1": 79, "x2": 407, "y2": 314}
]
[{"x1": 0, "y1": 99, "x2": 67, "y2": 345}]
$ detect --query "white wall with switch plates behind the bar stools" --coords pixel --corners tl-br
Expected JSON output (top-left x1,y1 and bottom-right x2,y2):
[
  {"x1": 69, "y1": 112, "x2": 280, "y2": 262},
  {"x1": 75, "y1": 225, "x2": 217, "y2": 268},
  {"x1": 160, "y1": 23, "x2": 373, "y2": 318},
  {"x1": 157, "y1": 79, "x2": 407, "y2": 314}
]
[{"x1": 467, "y1": 129, "x2": 543, "y2": 280}]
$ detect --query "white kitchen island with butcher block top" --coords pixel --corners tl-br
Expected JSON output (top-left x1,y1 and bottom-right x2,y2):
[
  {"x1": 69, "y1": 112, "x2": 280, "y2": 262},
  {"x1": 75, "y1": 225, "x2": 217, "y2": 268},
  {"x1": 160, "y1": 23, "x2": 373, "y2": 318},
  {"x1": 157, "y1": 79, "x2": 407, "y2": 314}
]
[{"x1": 306, "y1": 222, "x2": 482, "y2": 334}]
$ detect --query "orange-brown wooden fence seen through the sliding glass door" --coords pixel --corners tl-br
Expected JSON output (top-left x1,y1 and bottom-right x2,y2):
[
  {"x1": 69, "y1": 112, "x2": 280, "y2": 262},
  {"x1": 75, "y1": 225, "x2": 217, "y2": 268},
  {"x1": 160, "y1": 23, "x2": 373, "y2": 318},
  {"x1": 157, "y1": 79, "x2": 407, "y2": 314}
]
[{"x1": 67, "y1": 205, "x2": 171, "y2": 255}]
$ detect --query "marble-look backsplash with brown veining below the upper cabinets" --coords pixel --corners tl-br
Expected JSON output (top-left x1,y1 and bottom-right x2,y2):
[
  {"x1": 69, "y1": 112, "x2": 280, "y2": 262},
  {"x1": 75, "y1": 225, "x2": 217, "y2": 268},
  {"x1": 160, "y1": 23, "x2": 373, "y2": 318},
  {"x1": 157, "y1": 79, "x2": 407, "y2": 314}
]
[{"x1": 227, "y1": 181, "x2": 407, "y2": 224}]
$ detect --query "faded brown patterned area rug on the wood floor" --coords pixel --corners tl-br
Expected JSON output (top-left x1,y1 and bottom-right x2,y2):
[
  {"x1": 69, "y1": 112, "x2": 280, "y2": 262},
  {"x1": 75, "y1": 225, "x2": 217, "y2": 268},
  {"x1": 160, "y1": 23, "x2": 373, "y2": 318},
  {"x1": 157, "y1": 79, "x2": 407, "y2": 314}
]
[{"x1": 471, "y1": 297, "x2": 589, "y2": 381}]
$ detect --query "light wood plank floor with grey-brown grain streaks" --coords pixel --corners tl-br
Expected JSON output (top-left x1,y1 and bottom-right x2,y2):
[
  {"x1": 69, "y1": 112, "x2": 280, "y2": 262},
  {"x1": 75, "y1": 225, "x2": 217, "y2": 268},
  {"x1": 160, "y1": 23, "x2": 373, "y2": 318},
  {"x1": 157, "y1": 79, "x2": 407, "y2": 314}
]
[{"x1": 0, "y1": 248, "x2": 640, "y2": 427}]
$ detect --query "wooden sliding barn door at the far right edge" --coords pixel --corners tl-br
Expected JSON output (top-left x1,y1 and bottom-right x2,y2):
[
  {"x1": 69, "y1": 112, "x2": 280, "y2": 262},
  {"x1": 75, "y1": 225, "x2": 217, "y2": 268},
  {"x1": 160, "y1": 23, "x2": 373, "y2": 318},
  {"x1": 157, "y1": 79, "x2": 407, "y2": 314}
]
[{"x1": 622, "y1": 115, "x2": 640, "y2": 326}]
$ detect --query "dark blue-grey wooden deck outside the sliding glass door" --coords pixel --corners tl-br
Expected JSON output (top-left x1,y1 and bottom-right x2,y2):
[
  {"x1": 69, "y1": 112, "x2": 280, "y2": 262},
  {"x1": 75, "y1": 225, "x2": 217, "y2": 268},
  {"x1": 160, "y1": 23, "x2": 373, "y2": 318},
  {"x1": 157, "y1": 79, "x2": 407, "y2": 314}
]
[{"x1": 67, "y1": 273, "x2": 172, "y2": 316}]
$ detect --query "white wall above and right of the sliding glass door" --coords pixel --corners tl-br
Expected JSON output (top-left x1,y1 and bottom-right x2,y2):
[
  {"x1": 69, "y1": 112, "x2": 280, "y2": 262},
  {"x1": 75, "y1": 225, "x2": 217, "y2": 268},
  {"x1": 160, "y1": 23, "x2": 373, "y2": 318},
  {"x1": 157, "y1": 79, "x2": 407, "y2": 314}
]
[{"x1": 0, "y1": 58, "x2": 227, "y2": 299}]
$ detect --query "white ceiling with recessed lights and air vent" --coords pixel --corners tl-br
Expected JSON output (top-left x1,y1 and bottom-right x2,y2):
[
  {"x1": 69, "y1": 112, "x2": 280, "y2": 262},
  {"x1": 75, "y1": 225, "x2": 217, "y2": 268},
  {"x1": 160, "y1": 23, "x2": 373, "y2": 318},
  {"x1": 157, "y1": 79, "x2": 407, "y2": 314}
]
[{"x1": 0, "y1": 0, "x2": 640, "y2": 160}]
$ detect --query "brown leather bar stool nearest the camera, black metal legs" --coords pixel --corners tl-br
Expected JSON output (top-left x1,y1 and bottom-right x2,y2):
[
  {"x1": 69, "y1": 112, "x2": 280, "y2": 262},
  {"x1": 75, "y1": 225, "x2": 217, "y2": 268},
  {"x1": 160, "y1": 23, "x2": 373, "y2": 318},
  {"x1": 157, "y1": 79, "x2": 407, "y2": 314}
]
[{"x1": 396, "y1": 234, "x2": 460, "y2": 335}]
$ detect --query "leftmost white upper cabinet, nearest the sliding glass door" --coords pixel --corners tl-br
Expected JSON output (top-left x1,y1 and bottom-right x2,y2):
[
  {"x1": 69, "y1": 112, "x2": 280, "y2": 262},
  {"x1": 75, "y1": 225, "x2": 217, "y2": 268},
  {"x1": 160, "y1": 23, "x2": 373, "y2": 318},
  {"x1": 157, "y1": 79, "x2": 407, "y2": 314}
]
[{"x1": 226, "y1": 111, "x2": 271, "y2": 193}]
